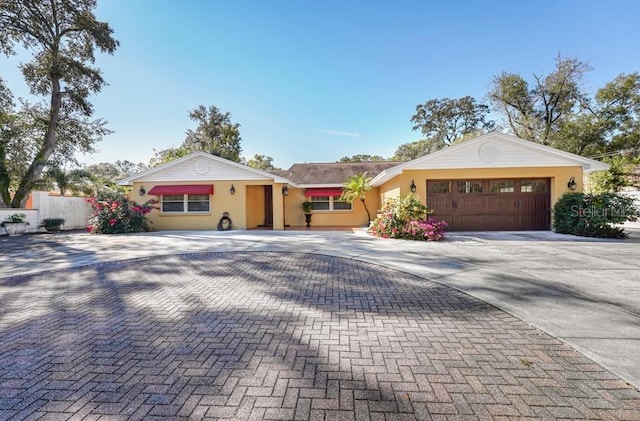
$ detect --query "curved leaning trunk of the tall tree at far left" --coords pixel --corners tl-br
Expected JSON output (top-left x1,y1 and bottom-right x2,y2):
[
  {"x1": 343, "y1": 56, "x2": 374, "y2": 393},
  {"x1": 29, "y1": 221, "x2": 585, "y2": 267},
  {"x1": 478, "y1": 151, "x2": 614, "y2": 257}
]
[{"x1": 11, "y1": 75, "x2": 62, "y2": 208}]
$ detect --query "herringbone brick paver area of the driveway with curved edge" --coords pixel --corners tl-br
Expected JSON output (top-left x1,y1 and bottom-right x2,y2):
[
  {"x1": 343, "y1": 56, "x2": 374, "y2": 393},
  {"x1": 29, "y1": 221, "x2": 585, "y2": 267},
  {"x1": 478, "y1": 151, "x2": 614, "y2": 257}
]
[{"x1": 0, "y1": 252, "x2": 640, "y2": 420}]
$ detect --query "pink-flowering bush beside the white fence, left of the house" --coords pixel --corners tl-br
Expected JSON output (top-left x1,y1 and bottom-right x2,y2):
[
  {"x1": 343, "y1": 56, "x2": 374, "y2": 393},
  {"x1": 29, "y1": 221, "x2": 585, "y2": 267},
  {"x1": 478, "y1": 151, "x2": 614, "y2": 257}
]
[{"x1": 86, "y1": 197, "x2": 156, "y2": 234}]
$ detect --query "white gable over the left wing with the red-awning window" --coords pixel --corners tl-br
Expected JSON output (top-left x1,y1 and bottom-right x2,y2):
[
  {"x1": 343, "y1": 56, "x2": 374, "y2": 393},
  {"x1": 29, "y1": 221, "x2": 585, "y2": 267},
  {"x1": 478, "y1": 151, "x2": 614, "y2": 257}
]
[{"x1": 118, "y1": 152, "x2": 293, "y2": 186}]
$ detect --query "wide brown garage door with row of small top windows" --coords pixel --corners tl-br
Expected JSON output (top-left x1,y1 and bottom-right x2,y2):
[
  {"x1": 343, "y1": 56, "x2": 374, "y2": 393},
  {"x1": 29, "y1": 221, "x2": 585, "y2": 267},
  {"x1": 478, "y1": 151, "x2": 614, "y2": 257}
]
[{"x1": 427, "y1": 178, "x2": 551, "y2": 231}]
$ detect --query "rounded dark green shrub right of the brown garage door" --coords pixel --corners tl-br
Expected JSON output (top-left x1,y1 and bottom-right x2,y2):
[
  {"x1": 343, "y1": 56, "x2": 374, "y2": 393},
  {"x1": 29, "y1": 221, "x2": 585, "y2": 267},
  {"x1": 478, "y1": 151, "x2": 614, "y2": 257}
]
[{"x1": 553, "y1": 193, "x2": 640, "y2": 238}]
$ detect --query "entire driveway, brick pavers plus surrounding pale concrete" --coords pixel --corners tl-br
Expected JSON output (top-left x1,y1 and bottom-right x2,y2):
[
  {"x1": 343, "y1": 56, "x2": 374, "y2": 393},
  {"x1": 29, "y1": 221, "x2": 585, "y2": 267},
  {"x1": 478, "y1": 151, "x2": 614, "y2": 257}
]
[{"x1": 0, "y1": 232, "x2": 640, "y2": 419}]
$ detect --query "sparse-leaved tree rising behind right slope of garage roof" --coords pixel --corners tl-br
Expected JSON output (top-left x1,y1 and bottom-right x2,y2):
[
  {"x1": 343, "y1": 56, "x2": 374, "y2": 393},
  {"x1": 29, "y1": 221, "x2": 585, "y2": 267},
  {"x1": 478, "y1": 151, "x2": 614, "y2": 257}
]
[{"x1": 488, "y1": 56, "x2": 590, "y2": 145}]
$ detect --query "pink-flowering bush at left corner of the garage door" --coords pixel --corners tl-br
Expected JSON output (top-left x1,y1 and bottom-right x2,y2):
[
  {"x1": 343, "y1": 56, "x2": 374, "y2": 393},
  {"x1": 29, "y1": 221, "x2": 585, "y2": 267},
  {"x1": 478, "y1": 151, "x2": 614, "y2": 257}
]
[{"x1": 369, "y1": 194, "x2": 447, "y2": 241}]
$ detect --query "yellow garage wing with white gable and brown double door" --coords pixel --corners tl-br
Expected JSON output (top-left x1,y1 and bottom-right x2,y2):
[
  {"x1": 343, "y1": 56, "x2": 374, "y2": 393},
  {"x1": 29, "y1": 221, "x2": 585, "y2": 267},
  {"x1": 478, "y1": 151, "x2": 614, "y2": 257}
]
[{"x1": 371, "y1": 132, "x2": 609, "y2": 231}]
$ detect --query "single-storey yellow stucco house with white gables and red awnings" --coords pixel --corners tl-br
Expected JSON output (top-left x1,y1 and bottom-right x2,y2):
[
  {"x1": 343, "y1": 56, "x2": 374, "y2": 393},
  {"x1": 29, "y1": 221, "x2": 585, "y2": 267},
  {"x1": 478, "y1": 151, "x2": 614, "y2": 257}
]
[{"x1": 119, "y1": 132, "x2": 608, "y2": 231}]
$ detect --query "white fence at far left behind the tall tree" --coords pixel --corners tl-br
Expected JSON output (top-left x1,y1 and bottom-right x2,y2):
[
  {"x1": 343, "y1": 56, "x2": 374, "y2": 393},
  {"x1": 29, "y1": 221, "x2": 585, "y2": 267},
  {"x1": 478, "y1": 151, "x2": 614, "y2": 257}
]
[{"x1": 0, "y1": 191, "x2": 91, "y2": 234}]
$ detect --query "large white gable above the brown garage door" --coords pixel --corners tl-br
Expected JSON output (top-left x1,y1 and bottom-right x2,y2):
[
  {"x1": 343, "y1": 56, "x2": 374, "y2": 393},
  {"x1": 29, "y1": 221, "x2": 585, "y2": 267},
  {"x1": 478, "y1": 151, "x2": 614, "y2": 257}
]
[{"x1": 371, "y1": 132, "x2": 609, "y2": 186}]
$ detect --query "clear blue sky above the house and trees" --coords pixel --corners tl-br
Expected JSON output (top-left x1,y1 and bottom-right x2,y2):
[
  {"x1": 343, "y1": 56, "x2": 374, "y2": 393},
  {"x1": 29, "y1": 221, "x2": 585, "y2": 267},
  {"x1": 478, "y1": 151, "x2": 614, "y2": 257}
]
[{"x1": 0, "y1": 0, "x2": 640, "y2": 168}]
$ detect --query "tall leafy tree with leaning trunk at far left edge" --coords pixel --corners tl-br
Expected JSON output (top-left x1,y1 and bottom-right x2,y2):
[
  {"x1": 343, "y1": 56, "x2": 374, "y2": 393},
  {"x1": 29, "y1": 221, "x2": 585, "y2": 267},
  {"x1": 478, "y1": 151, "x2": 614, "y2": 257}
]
[{"x1": 0, "y1": 0, "x2": 118, "y2": 207}]
